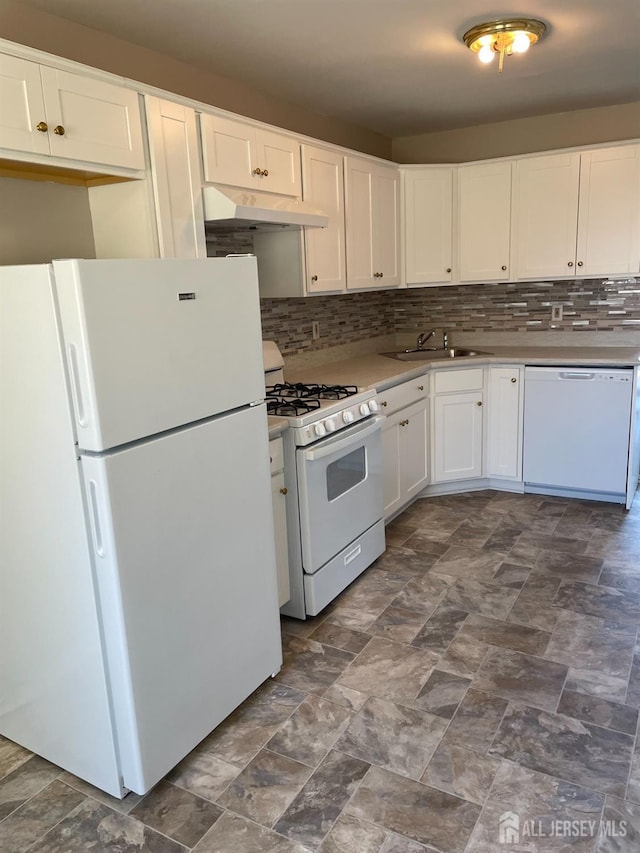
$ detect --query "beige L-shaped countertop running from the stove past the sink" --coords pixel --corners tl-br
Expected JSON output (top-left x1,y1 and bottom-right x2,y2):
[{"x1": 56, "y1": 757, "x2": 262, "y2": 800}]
[{"x1": 284, "y1": 346, "x2": 640, "y2": 392}]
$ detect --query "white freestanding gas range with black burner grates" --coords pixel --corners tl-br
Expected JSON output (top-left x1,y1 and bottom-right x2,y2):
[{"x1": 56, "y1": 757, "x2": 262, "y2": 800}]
[{"x1": 263, "y1": 341, "x2": 385, "y2": 619}]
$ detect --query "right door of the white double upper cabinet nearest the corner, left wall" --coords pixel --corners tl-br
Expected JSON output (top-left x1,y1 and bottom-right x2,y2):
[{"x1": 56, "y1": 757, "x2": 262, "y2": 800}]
[{"x1": 373, "y1": 165, "x2": 400, "y2": 287}]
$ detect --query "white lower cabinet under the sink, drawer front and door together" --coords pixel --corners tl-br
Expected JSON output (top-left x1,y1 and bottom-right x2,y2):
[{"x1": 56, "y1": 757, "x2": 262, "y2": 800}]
[{"x1": 432, "y1": 367, "x2": 484, "y2": 483}]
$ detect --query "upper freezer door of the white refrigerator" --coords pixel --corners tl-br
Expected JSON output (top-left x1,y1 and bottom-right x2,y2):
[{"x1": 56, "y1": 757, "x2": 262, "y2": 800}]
[{"x1": 53, "y1": 258, "x2": 264, "y2": 451}]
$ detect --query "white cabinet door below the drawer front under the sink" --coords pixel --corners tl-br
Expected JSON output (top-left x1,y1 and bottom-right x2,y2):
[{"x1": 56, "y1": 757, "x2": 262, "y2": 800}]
[{"x1": 433, "y1": 391, "x2": 482, "y2": 483}]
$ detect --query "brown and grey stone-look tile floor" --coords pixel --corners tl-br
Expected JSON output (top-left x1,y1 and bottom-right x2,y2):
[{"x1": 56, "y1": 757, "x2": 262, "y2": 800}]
[{"x1": 0, "y1": 491, "x2": 640, "y2": 853}]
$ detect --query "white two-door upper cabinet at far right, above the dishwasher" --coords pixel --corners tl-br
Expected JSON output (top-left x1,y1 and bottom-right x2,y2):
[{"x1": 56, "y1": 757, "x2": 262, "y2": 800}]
[{"x1": 515, "y1": 145, "x2": 640, "y2": 278}]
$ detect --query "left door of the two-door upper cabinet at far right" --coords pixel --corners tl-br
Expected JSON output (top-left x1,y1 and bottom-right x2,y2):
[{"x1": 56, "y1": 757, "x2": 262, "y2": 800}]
[{"x1": 515, "y1": 154, "x2": 580, "y2": 278}]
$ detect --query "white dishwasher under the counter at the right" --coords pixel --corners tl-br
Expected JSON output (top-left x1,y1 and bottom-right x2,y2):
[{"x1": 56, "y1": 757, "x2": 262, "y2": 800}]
[{"x1": 523, "y1": 367, "x2": 633, "y2": 503}]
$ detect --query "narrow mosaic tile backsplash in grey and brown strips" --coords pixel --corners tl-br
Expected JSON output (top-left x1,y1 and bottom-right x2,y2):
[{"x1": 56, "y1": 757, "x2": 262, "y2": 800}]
[{"x1": 261, "y1": 276, "x2": 640, "y2": 355}]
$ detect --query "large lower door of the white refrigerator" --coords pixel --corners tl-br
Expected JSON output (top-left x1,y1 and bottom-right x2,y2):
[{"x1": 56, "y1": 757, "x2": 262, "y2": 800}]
[{"x1": 82, "y1": 404, "x2": 282, "y2": 793}]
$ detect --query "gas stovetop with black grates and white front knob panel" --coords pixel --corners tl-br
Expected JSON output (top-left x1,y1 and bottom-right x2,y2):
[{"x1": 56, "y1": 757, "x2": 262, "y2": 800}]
[{"x1": 265, "y1": 382, "x2": 378, "y2": 446}]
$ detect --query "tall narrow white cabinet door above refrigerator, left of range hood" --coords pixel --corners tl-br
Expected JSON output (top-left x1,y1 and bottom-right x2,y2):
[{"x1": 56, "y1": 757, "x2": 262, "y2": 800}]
[{"x1": 147, "y1": 97, "x2": 207, "y2": 258}]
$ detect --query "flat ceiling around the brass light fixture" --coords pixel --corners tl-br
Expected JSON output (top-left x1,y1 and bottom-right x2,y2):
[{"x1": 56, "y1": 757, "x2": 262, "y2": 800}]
[{"x1": 23, "y1": 0, "x2": 640, "y2": 137}]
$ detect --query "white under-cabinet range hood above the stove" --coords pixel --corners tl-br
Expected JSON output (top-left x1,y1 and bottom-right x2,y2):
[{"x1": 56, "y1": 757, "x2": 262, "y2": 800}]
[{"x1": 202, "y1": 184, "x2": 329, "y2": 228}]
